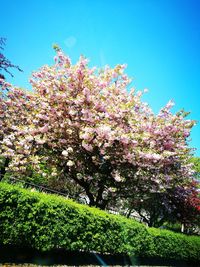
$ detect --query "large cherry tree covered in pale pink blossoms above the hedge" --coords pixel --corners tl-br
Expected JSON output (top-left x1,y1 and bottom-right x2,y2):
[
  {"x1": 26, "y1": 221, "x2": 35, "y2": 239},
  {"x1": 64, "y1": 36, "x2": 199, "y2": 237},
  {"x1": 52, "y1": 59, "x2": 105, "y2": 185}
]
[{"x1": 0, "y1": 48, "x2": 194, "y2": 209}]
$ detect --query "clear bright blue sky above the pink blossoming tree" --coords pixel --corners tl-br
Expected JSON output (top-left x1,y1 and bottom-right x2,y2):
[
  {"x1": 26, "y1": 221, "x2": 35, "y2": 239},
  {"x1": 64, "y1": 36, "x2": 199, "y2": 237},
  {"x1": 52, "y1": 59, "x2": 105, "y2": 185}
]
[{"x1": 0, "y1": 0, "x2": 200, "y2": 156}]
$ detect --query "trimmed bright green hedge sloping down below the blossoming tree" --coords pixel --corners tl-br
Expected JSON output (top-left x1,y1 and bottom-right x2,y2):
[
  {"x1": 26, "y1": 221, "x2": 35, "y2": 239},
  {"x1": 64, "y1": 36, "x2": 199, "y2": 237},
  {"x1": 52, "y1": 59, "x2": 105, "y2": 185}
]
[{"x1": 0, "y1": 182, "x2": 200, "y2": 262}]
